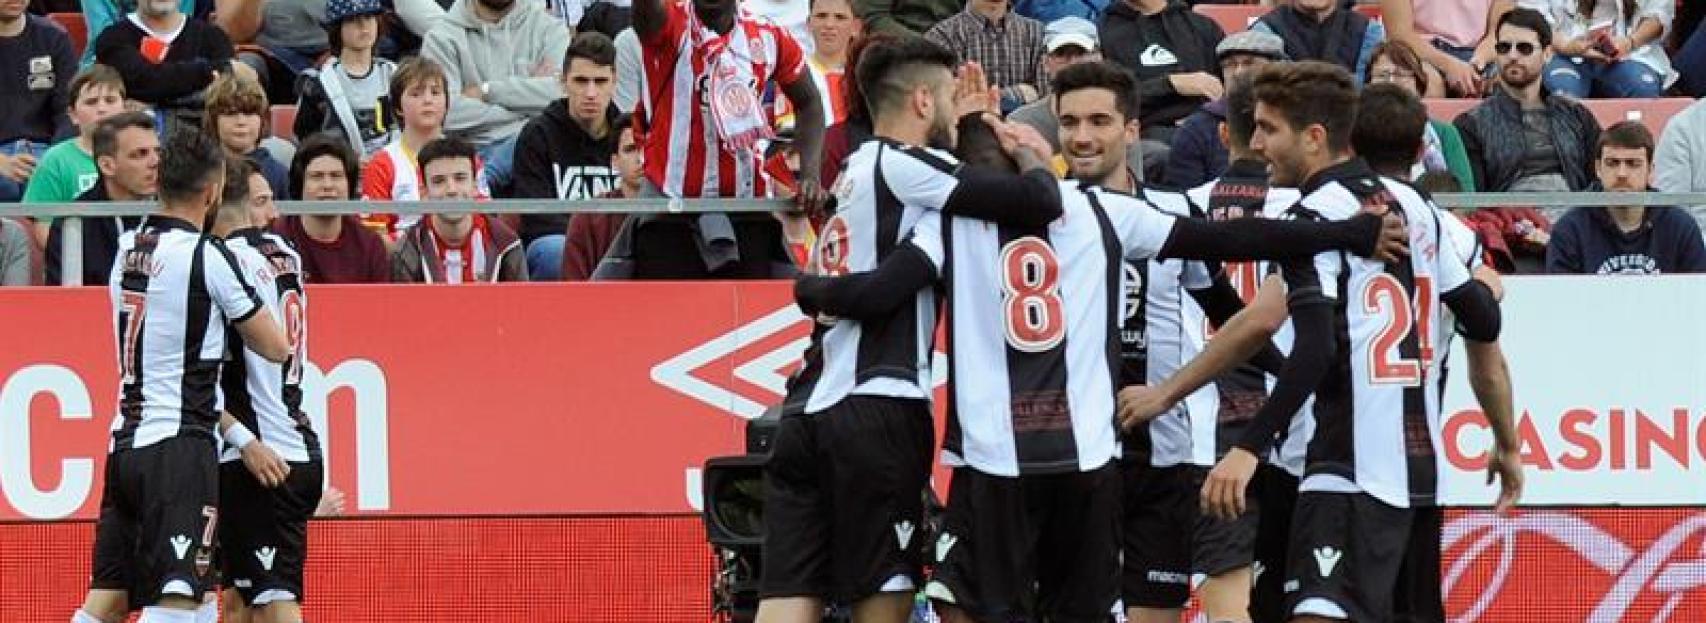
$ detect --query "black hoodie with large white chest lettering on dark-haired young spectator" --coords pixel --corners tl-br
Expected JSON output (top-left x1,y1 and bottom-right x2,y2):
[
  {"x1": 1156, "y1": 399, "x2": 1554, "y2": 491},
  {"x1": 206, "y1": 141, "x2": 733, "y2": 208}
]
[{"x1": 514, "y1": 99, "x2": 619, "y2": 244}]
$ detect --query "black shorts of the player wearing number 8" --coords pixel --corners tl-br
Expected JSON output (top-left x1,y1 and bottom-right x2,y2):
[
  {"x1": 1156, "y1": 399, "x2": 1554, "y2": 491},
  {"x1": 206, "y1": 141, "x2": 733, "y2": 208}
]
[{"x1": 925, "y1": 463, "x2": 1121, "y2": 623}]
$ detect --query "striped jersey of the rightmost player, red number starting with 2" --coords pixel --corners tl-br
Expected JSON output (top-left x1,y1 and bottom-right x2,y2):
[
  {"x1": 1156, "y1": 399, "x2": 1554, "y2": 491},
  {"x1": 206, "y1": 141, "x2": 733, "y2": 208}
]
[{"x1": 1286, "y1": 160, "x2": 1471, "y2": 507}]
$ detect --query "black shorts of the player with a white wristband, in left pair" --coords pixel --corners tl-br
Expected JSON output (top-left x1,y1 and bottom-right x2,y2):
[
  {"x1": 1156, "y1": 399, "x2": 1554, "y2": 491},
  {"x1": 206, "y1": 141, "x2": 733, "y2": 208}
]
[{"x1": 218, "y1": 461, "x2": 324, "y2": 606}]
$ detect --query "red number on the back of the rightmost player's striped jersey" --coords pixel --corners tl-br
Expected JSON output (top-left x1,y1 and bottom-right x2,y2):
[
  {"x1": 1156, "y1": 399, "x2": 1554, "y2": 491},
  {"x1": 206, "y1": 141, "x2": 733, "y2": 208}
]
[{"x1": 1361, "y1": 273, "x2": 1435, "y2": 387}]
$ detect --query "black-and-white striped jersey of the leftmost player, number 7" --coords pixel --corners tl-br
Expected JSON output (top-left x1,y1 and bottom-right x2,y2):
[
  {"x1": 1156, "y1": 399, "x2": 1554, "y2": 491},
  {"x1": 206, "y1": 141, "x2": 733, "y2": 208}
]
[{"x1": 107, "y1": 215, "x2": 263, "y2": 451}]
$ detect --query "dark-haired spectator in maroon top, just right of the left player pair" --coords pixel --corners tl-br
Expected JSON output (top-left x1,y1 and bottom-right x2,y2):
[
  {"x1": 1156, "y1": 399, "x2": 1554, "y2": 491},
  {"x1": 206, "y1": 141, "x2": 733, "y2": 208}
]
[{"x1": 273, "y1": 135, "x2": 391, "y2": 283}]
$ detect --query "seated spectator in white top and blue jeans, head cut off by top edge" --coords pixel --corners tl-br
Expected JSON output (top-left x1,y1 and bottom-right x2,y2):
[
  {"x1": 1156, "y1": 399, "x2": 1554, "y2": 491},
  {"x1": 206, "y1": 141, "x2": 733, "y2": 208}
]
[{"x1": 1522, "y1": 0, "x2": 1677, "y2": 99}]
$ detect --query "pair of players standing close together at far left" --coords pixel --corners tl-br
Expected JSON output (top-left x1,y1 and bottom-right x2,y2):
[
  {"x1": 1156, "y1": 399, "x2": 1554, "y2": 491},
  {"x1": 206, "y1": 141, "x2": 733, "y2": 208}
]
[{"x1": 72, "y1": 128, "x2": 322, "y2": 623}]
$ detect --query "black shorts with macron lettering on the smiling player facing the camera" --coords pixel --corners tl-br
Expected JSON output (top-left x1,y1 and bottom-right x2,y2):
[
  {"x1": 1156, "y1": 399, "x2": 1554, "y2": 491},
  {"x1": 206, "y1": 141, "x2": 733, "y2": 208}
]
[{"x1": 1119, "y1": 461, "x2": 1198, "y2": 609}]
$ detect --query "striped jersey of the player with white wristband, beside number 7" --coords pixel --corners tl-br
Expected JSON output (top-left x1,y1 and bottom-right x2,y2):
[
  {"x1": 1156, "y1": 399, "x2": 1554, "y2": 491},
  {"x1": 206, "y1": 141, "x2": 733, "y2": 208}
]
[{"x1": 220, "y1": 229, "x2": 321, "y2": 463}]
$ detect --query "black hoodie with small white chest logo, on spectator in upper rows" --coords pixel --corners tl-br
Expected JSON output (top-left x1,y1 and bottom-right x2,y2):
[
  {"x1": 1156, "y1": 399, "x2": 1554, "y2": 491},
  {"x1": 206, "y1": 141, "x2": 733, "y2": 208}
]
[{"x1": 1099, "y1": 0, "x2": 1225, "y2": 128}]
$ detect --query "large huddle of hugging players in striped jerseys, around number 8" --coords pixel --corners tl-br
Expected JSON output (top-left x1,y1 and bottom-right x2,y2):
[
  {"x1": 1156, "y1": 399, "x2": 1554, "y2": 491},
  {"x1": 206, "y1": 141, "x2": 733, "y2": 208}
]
[{"x1": 757, "y1": 38, "x2": 1522, "y2": 623}]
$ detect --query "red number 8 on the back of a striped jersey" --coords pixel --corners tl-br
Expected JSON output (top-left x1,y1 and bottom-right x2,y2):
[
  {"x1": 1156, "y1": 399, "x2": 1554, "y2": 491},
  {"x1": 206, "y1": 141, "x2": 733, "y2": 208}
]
[{"x1": 1001, "y1": 236, "x2": 1066, "y2": 353}]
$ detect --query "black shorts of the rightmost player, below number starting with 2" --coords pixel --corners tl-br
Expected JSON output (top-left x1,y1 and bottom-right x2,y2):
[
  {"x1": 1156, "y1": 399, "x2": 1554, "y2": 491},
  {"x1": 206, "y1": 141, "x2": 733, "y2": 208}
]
[{"x1": 1286, "y1": 492, "x2": 1414, "y2": 621}]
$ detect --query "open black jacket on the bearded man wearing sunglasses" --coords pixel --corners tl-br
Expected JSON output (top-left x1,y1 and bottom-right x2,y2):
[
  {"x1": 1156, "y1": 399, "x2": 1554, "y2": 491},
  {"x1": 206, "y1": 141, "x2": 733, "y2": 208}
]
[{"x1": 1454, "y1": 89, "x2": 1600, "y2": 193}]
